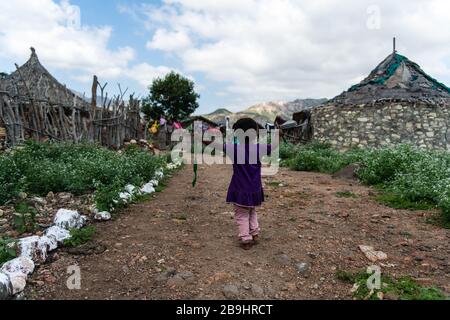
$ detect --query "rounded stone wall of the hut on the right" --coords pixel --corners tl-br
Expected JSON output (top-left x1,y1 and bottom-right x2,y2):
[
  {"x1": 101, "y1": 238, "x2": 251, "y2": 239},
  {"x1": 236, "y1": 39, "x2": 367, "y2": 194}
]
[{"x1": 312, "y1": 102, "x2": 450, "y2": 150}]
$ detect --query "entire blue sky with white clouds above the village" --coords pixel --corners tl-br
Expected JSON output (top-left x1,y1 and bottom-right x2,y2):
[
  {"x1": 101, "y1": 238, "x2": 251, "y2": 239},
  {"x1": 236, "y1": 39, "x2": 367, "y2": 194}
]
[{"x1": 0, "y1": 0, "x2": 450, "y2": 113}]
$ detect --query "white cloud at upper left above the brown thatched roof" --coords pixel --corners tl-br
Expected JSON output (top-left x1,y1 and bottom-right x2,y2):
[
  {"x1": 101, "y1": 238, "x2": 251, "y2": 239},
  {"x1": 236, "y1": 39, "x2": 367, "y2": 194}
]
[{"x1": 0, "y1": 0, "x2": 178, "y2": 92}]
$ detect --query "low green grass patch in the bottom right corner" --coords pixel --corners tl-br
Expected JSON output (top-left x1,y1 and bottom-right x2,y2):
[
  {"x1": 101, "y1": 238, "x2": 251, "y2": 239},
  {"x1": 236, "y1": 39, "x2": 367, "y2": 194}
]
[{"x1": 336, "y1": 271, "x2": 448, "y2": 300}]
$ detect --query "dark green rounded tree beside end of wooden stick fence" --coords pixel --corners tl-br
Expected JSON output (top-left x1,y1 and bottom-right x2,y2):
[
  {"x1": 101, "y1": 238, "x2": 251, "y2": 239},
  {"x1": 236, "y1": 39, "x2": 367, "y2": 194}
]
[{"x1": 142, "y1": 71, "x2": 200, "y2": 120}]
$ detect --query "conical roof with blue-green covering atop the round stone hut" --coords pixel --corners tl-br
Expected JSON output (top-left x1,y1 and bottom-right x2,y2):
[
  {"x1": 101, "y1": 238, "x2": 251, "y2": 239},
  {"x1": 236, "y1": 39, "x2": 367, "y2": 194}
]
[{"x1": 331, "y1": 52, "x2": 450, "y2": 105}]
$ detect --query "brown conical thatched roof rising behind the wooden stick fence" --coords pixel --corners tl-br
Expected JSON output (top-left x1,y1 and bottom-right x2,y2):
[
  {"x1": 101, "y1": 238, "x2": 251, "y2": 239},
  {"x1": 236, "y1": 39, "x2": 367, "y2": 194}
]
[{"x1": 0, "y1": 48, "x2": 89, "y2": 108}]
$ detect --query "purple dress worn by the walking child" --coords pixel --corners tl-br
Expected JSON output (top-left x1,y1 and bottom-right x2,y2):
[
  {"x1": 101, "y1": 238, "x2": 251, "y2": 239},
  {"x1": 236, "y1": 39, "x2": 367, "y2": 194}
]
[{"x1": 225, "y1": 144, "x2": 271, "y2": 207}]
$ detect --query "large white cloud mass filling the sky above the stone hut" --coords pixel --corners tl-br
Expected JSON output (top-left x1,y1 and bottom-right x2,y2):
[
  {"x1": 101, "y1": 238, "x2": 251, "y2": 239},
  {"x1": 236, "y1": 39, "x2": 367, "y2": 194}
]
[{"x1": 142, "y1": 0, "x2": 450, "y2": 104}]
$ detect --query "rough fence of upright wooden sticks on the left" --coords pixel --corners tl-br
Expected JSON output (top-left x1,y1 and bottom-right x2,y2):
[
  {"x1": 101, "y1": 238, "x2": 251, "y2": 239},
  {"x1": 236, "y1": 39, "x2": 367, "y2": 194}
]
[{"x1": 0, "y1": 77, "x2": 144, "y2": 148}]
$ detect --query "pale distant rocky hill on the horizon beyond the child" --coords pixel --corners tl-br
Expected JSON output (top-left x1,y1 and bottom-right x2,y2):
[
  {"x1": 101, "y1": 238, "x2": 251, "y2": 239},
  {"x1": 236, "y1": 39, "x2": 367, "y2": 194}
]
[{"x1": 204, "y1": 99, "x2": 328, "y2": 125}]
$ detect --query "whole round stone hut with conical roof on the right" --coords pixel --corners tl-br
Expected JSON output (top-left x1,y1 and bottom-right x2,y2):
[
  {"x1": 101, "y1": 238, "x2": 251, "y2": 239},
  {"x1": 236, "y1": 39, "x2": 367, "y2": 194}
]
[{"x1": 311, "y1": 52, "x2": 450, "y2": 150}]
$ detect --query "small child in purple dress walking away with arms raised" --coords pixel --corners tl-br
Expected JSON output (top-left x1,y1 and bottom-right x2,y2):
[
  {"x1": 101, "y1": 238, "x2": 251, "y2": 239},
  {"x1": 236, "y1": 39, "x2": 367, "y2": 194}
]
[{"x1": 225, "y1": 118, "x2": 271, "y2": 250}]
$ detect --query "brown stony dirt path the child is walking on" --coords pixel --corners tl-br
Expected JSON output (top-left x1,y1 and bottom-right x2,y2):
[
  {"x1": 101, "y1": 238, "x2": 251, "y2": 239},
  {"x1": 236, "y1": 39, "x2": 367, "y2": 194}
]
[{"x1": 26, "y1": 166, "x2": 450, "y2": 299}]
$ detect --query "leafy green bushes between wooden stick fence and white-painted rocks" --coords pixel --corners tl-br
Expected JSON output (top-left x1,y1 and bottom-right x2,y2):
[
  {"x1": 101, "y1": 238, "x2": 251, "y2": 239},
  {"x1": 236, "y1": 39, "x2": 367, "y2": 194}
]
[{"x1": 0, "y1": 142, "x2": 165, "y2": 210}]
